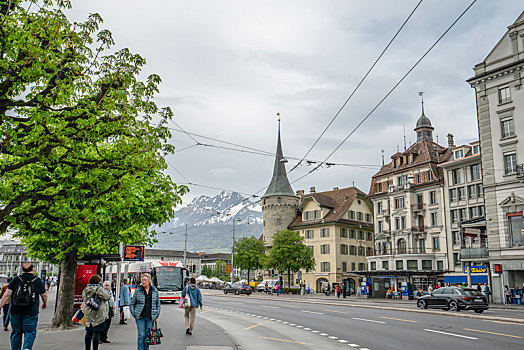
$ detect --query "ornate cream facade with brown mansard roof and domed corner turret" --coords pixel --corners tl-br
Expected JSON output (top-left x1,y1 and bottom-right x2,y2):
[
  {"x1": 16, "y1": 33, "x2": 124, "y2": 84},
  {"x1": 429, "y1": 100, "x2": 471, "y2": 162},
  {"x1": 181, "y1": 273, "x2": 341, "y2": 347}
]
[{"x1": 367, "y1": 105, "x2": 451, "y2": 293}]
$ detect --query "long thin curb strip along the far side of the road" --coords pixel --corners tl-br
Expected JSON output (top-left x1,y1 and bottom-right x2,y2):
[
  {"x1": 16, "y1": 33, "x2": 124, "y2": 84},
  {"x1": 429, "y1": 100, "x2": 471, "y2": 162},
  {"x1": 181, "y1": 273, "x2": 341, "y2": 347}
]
[{"x1": 208, "y1": 294, "x2": 524, "y2": 324}]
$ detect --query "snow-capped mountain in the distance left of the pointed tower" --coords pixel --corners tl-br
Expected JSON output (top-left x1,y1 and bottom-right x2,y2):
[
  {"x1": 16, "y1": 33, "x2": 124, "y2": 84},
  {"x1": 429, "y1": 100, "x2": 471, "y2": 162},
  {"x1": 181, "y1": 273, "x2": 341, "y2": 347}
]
[{"x1": 155, "y1": 191, "x2": 263, "y2": 252}]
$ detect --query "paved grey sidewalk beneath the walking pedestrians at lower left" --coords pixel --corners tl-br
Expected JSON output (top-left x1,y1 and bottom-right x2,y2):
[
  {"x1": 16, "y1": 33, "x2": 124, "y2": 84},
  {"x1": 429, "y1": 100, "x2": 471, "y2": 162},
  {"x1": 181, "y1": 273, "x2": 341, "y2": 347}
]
[{"x1": 0, "y1": 291, "x2": 237, "y2": 350}]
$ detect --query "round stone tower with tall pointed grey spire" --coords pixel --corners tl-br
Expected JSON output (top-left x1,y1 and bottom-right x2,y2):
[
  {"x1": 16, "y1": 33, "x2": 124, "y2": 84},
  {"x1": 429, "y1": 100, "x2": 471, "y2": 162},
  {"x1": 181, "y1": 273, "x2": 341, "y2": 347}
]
[{"x1": 262, "y1": 119, "x2": 300, "y2": 247}]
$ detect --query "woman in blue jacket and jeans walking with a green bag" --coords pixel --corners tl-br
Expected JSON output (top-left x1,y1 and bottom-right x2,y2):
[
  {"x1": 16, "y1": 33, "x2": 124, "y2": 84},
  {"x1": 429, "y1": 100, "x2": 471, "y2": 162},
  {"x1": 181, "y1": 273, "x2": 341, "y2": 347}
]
[{"x1": 129, "y1": 273, "x2": 160, "y2": 350}]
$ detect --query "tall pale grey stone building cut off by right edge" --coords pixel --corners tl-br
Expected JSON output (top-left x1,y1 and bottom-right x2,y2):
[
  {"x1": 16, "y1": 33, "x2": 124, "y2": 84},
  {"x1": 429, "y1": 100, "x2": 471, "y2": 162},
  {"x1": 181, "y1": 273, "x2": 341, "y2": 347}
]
[{"x1": 468, "y1": 12, "x2": 524, "y2": 302}]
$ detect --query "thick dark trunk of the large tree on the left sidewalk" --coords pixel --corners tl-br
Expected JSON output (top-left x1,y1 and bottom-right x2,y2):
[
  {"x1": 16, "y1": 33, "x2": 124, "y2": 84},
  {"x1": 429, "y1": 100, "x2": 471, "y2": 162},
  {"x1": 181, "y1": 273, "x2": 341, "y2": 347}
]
[{"x1": 53, "y1": 250, "x2": 77, "y2": 329}]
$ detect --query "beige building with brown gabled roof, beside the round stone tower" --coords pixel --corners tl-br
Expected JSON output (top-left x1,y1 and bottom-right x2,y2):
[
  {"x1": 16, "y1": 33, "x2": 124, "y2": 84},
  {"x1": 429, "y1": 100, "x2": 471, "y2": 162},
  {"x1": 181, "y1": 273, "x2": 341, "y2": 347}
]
[{"x1": 289, "y1": 187, "x2": 373, "y2": 292}]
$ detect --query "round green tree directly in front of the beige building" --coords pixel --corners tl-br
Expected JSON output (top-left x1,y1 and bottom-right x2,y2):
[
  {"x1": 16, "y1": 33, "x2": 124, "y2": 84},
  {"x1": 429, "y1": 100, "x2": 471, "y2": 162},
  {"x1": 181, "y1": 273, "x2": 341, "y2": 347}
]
[{"x1": 266, "y1": 230, "x2": 315, "y2": 290}]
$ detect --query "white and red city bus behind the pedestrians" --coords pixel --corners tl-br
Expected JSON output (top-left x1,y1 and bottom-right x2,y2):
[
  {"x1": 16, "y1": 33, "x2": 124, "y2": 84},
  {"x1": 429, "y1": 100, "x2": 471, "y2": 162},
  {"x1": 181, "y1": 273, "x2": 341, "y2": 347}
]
[{"x1": 122, "y1": 260, "x2": 189, "y2": 303}]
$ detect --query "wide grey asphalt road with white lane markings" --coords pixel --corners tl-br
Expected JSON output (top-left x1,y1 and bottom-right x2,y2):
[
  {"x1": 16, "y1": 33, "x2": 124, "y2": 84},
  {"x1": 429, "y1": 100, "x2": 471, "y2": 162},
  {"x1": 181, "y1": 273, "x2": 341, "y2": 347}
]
[{"x1": 204, "y1": 295, "x2": 524, "y2": 350}]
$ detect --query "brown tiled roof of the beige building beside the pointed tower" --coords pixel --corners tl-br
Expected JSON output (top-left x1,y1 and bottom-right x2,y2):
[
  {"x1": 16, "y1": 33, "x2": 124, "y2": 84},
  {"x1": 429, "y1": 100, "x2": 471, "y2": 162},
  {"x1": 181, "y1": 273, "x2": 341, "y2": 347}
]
[{"x1": 289, "y1": 187, "x2": 373, "y2": 229}]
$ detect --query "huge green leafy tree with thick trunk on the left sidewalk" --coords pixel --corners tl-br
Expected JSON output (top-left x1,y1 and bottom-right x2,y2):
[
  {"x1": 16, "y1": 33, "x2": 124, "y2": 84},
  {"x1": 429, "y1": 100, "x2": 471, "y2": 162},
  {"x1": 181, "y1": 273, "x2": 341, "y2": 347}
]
[{"x1": 0, "y1": 0, "x2": 187, "y2": 328}]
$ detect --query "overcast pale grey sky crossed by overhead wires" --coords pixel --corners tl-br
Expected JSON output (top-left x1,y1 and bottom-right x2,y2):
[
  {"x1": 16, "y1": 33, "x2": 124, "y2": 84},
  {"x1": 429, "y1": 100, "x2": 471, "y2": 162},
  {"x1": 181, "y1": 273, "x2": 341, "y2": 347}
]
[{"x1": 69, "y1": 0, "x2": 524, "y2": 200}]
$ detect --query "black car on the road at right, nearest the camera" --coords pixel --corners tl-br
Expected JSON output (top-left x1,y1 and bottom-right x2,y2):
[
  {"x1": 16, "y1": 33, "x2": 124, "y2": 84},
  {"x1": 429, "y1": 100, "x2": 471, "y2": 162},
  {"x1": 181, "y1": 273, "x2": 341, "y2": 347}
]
[{"x1": 417, "y1": 287, "x2": 489, "y2": 314}]
